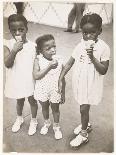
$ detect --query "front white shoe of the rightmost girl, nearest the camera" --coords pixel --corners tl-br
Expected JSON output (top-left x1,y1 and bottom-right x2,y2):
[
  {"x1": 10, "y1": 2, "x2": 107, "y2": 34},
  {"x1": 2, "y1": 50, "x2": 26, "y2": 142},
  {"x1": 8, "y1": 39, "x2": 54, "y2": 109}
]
[{"x1": 70, "y1": 134, "x2": 89, "y2": 147}]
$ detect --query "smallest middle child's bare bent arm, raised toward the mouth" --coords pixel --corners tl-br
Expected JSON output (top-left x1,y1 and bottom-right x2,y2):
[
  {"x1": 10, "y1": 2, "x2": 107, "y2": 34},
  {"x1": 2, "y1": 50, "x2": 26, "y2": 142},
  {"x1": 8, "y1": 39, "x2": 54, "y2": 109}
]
[{"x1": 33, "y1": 58, "x2": 58, "y2": 80}]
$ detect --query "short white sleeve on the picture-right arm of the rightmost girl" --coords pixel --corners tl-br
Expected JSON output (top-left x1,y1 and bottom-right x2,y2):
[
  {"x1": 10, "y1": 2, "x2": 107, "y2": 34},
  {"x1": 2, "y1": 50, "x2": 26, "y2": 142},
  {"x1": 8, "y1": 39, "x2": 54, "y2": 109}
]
[{"x1": 101, "y1": 45, "x2": 110, "y2": 61}]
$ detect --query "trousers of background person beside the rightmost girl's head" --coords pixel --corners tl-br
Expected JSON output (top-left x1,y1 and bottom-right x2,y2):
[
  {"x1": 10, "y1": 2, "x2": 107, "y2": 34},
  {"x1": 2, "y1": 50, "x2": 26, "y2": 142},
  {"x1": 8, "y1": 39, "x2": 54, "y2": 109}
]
[{"x1": 68, "y1": 3, "x2": 85, "y2": 31}]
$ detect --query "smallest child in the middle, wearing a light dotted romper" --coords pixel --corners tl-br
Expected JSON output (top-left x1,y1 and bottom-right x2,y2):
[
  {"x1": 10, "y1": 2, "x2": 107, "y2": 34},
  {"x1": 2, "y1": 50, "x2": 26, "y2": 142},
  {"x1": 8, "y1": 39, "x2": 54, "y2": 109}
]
[{"x1": 33, "y1": 34, "x2": 64, "y2": 139}]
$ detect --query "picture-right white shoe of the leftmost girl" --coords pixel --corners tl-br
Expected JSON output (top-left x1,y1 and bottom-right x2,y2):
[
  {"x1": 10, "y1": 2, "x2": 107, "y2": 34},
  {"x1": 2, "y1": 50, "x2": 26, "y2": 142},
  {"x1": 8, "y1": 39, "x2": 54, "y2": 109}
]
[{"x1": 28, "y1": 120, "x2": 38, "y2": 136}]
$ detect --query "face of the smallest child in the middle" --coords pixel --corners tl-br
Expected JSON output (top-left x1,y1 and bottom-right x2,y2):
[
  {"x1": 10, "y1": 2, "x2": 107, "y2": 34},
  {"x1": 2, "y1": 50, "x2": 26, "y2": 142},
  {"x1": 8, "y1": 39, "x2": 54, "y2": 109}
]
[{"x1": 41, "y1": 40, "x2": 56, "y2": 60}]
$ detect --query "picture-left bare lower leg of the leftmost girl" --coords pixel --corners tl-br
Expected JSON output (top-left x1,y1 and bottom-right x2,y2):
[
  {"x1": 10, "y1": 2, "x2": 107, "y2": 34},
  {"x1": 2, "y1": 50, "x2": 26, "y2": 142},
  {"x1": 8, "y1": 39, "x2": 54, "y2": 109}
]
[{"x1": 16, "y1": 98, "x2": 25, "y2": 116}]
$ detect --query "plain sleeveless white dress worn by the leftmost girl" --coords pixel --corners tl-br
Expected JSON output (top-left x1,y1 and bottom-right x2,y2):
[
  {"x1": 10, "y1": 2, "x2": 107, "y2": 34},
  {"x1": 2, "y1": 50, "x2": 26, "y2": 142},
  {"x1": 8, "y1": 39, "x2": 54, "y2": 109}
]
[{"x1": 4, "y1": 39, "x2": 35, "y2": 99}]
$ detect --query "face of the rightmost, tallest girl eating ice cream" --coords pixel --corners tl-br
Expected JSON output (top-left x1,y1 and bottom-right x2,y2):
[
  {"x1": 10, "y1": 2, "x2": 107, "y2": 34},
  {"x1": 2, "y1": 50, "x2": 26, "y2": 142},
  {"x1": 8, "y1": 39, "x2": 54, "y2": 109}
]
[{"x1": 82, "y1": 23, "x2": 101, "y2": 41}]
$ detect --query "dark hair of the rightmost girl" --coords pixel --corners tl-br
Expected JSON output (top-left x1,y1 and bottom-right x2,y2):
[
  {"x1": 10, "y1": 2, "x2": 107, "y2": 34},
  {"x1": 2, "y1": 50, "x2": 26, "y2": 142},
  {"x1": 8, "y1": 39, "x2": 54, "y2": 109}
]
[{"x1": 80, "y1": 13, "x2": 102, "y2": 29}]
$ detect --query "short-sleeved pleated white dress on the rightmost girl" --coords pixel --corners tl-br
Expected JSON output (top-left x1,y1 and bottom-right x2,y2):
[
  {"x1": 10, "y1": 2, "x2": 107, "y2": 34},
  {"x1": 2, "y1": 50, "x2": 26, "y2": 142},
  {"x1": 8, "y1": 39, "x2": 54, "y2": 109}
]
[{"x1": 72, "y1": 39, "x2": 110, "y2": 105}]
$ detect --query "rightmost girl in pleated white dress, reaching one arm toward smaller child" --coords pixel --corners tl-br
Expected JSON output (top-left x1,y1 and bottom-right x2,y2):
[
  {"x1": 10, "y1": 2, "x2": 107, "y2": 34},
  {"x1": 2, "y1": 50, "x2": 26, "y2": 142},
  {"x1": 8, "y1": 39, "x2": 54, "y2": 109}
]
[{"x1": 59, "y1": 14, "x2": 110, "y2": 147}]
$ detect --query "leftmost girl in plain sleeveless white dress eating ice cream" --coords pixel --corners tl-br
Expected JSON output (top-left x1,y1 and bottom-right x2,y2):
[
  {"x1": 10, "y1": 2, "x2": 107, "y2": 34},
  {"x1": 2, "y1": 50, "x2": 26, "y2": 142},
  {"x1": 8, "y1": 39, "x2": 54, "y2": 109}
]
[{"x1": 4, "y1": 14, "x2": 38, "y2": 135}]
